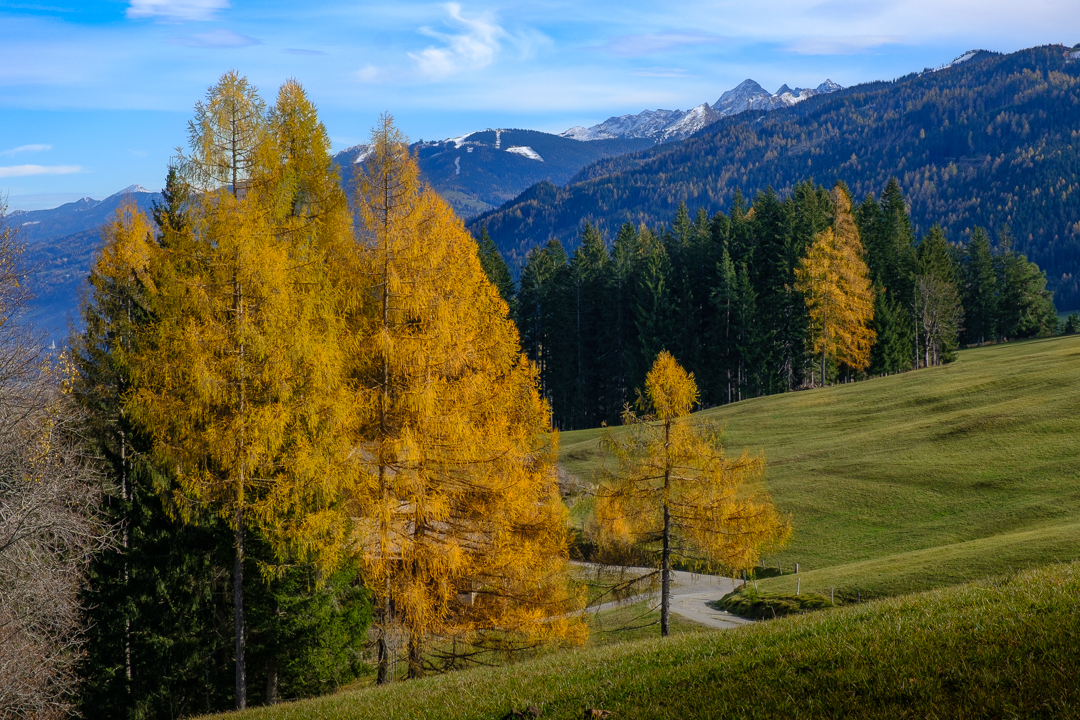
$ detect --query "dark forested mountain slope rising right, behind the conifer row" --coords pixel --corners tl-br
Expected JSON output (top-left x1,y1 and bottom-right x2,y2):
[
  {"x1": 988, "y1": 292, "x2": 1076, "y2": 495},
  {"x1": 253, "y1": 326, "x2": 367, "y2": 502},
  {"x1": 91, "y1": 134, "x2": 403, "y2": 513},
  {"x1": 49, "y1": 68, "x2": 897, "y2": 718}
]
[{"x1": 472, "y1": 45, "x2": 1080, "y2": 308}]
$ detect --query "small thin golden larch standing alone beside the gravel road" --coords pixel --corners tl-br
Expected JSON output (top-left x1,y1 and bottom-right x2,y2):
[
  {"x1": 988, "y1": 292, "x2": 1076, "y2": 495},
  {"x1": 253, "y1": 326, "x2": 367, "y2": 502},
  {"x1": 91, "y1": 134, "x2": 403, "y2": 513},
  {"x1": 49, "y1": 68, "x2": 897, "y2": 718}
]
[{"x1": 593, "y1": 351, "x2": 791, "y2": 636}]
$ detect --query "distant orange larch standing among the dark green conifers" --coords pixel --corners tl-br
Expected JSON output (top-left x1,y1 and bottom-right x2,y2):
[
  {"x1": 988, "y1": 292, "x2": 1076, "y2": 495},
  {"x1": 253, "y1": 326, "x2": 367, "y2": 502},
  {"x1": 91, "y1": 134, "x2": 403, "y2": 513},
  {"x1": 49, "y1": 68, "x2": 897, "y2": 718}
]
[{"x1": 795, "y1": 186, "x2": 877, "y2": 386}]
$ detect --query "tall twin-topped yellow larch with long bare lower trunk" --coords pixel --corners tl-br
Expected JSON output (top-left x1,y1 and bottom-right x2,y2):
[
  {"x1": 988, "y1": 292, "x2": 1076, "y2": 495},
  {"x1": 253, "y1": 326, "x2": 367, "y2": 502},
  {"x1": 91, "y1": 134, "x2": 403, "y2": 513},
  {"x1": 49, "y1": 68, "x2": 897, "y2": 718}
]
[{"x1": 127, "y1": 72, "x2": 349, "y2": 708}]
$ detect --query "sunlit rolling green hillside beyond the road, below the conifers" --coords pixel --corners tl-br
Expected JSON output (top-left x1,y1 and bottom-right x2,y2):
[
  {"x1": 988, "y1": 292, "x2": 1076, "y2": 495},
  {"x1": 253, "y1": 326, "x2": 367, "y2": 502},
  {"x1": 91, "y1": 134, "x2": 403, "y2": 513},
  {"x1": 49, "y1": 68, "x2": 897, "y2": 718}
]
[{"x1": 562, "y1": 336, "x2": 1080, "y2": 598}]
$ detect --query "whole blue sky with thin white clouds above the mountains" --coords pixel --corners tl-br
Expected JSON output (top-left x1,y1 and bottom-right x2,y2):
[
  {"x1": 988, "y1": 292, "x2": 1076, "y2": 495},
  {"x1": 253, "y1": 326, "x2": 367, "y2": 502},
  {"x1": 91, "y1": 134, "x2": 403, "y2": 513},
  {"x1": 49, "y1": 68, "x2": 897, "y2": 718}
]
[{"x1": 0, "y1": 0, "x2": 1080, "y2": 209}]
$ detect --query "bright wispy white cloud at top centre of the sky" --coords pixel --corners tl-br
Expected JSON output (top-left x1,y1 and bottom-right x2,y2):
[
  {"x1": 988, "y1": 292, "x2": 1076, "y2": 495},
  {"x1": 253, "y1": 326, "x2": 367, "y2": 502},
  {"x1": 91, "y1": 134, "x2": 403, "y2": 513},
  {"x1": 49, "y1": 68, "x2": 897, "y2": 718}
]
[{"x1": 408, "y1": 2, "x2": 509, "y2": 79}]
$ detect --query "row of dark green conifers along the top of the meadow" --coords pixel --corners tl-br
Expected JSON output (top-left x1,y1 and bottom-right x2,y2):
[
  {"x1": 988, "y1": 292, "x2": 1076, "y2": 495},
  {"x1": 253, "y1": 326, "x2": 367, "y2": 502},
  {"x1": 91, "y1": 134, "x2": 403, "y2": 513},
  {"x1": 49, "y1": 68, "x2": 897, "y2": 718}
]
[{"x1": 481, "y1": 180, "x2": 1056, "y2": 429}]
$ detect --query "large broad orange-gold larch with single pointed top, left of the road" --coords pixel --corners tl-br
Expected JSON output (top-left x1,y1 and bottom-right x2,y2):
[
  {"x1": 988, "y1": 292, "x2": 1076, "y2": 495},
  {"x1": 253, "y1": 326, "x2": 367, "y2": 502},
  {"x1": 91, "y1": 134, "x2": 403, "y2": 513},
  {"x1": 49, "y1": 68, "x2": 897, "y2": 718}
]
[{"x1": 350, "y1": 116, "x2": 582, "y2": 681}]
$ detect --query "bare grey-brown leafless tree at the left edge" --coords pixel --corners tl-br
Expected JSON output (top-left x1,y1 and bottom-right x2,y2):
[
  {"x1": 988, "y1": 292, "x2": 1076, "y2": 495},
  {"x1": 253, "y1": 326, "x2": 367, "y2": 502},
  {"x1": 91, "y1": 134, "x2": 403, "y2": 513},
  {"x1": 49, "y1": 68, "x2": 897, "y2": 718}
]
[{"x1": 0, "y1": 205, "x2": 110, "y2": 718}]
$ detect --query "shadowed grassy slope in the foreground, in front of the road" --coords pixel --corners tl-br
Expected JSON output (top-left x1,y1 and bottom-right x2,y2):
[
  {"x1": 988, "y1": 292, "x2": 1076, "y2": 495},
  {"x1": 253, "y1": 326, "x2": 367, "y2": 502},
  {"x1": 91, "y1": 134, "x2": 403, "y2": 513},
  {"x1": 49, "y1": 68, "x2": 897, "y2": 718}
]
[{"x1": 208, "y1": 563, "x2": 1080, "y2": 720}]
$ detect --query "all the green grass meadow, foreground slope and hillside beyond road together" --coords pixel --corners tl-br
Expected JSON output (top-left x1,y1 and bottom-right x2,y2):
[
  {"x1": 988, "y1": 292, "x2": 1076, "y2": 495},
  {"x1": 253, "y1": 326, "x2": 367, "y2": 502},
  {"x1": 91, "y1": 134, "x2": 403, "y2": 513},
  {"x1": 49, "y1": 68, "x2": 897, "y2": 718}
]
[{"x1": 200, "y1": 336, "x2": 1080, "y2": 720}]
